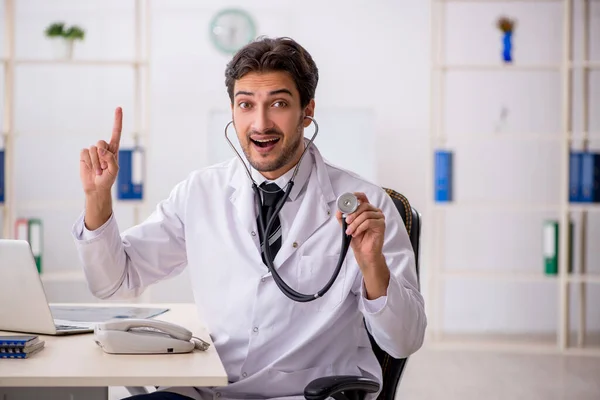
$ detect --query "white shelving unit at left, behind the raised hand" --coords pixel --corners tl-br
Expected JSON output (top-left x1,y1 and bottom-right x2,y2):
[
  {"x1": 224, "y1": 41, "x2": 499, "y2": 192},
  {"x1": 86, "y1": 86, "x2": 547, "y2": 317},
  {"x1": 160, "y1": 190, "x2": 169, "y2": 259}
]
[{"x1": 0, "y1": 0, "x2": 150, "y2": 301}]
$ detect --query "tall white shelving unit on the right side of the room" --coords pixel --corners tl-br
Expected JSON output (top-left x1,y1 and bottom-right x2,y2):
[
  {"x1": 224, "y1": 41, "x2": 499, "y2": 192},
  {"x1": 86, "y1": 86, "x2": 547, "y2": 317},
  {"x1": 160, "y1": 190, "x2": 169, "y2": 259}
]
[{"x1": 425, "y1": 0, "x2": 600, "y2": 356}]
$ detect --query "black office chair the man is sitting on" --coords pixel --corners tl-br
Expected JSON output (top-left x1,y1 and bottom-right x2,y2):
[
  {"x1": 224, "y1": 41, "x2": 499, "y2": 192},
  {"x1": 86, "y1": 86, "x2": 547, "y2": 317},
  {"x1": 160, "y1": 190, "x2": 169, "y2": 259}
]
[{"x1": 304, "y1": 188, "x2": 421, "y2": 400}]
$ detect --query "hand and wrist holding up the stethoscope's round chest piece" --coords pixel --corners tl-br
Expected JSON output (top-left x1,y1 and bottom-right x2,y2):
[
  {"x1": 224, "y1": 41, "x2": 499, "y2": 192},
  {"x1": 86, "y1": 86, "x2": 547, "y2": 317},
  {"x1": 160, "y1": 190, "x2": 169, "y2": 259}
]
[{"x1": 336, "y1": 193, "x2": 390, "y2": 299}]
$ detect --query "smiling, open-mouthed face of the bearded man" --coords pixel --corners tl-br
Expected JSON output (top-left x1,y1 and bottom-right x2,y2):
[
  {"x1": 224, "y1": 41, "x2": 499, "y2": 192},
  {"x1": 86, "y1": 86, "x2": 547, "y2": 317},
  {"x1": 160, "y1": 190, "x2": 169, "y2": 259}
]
[{"x1": 232, "y1": 71, "x2": 314, "y2": 179}]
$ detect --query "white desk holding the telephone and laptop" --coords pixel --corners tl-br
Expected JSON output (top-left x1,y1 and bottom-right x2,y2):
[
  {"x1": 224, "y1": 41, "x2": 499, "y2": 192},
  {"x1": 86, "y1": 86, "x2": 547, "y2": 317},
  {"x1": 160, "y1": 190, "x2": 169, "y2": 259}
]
[{"x1": 0, "y1": 303, "x2": 227, "y2": 400}]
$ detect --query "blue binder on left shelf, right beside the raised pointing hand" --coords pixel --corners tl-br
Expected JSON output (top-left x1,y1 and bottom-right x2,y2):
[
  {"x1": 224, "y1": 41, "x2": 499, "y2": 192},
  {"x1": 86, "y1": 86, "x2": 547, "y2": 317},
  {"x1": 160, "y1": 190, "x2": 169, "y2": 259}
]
[{"x1": 117, "y1": 147, "x2": 144, "y2": 200}]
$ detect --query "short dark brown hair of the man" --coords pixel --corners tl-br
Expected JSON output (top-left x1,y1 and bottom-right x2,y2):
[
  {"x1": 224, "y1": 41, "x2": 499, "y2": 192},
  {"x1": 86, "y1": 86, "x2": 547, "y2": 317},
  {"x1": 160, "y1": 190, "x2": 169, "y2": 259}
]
[{"x1": 225, "y1": 37, "x2": 319, "y2": 108}]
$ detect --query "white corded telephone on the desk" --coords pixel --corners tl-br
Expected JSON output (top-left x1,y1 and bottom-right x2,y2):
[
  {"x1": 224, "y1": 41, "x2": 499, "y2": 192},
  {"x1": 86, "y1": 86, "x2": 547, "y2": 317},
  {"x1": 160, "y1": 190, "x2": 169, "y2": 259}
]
[{"x1": 94, "y1": 318, "x2": 210, "y2": 354}]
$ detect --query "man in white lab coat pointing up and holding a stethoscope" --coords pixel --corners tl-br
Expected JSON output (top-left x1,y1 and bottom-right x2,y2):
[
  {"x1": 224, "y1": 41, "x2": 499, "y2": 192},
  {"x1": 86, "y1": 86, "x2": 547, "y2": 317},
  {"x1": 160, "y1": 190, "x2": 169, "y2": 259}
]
[{"x1": 73, "y1": 38, "x2": 427, "y2": 399}]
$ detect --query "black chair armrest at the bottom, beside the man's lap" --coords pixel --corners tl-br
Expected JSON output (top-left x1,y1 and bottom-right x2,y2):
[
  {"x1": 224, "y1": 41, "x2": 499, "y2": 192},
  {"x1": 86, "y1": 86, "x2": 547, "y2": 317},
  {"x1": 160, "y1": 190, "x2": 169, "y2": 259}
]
[{"x1": 304, "y1": 375, "x2": 379, "y2": 400}]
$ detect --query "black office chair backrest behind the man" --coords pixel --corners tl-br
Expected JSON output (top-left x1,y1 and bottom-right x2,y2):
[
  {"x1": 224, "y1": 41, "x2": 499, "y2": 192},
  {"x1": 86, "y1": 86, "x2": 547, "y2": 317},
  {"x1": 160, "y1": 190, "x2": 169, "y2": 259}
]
[{"x1": 369, "y1": 188, "x2": 421, "y2": 400}]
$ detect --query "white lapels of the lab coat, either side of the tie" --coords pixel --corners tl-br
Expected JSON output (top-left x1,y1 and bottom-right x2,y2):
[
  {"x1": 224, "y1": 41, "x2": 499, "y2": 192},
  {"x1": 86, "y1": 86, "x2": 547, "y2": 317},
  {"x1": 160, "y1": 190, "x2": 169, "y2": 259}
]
[{"x1": 229, "y1": 140, "x2": 336, "y2": 269}]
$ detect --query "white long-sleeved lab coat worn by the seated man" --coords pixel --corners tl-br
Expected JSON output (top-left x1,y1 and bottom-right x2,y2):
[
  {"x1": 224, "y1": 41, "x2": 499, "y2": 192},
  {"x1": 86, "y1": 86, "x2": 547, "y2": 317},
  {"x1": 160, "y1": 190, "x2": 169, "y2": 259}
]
[{"x1": 73, "y1": 144, "x2": 427, "y2": 399}]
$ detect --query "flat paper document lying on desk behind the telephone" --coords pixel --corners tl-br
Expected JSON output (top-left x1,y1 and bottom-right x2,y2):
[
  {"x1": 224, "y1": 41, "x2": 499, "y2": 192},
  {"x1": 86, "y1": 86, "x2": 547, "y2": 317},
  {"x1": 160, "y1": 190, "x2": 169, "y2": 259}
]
[{"x1": 50, "y1": 305, "x2": 169, "y2": 323}]
